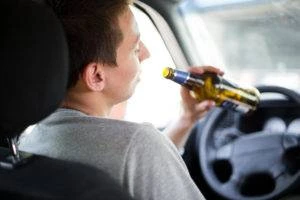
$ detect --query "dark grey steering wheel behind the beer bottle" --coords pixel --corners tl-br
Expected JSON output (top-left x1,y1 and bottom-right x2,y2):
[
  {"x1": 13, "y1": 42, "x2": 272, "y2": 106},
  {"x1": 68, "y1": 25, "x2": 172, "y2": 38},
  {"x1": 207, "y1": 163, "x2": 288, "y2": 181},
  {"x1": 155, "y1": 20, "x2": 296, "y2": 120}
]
[{"x1": 196, "y1": 86, "x2": 300, "y2": 200}]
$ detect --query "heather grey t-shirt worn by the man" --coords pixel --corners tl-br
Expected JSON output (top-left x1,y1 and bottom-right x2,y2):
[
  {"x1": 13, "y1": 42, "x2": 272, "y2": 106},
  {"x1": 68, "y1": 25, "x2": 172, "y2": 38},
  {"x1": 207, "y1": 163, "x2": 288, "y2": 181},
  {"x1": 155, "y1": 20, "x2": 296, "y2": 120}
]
[{"x1": 19, "y1": 109, "x2": 204, "y2": 200}]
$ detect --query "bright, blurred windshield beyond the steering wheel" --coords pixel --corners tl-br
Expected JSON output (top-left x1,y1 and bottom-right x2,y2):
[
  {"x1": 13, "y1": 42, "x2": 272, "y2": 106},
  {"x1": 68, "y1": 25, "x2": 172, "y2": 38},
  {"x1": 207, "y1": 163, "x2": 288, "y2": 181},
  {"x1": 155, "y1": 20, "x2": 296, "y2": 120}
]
[{"x1": 181, "y1": 0, "x2": 300, "y2": 91}]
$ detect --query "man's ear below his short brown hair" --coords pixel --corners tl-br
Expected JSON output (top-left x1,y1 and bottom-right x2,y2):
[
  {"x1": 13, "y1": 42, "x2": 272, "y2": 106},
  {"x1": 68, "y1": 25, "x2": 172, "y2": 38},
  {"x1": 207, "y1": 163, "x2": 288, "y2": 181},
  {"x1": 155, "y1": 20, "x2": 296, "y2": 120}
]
[{"x1": 82, "y1": 62, "x2": 105, "y2": 91}]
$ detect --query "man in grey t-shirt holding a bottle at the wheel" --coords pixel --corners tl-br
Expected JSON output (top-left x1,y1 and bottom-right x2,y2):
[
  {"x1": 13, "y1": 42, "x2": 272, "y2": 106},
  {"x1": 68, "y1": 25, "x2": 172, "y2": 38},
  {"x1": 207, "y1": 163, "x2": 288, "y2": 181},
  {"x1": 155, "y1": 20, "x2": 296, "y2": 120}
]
[{"x1": 20, "y1": 0, "x2": 222, "y2": 200}]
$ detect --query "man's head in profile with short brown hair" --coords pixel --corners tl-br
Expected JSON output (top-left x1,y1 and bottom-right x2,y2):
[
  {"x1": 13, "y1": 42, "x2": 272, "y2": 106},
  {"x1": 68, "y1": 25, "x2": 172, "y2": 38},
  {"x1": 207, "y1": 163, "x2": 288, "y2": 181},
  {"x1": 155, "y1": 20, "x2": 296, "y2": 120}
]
[{"x1": 48, "y1": 0, "x2": 149, "y2": 113}]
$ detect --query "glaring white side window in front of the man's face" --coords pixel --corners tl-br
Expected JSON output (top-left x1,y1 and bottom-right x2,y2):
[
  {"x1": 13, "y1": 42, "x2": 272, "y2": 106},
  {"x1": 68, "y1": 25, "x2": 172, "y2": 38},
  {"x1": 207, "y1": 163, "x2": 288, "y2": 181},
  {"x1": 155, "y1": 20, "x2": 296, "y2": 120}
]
[{"x1": 110, "y1": 8, "x2": 180, "y2": 128}]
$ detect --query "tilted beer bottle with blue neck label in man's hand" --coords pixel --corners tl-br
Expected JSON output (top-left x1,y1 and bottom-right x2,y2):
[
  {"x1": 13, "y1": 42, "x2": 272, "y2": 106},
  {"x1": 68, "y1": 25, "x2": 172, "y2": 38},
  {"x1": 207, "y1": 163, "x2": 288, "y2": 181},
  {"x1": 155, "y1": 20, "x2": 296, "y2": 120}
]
[{"x1": 163, "y1": 67, "x2": 260, "y2": 113}]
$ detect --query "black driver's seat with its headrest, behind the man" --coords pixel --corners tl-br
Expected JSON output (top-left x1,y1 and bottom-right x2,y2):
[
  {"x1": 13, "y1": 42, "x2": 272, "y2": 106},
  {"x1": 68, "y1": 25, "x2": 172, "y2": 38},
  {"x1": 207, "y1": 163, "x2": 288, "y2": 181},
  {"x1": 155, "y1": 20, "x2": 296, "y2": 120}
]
[{"x1": 0, "y1": 0, "x2": 131, "y2": 200}]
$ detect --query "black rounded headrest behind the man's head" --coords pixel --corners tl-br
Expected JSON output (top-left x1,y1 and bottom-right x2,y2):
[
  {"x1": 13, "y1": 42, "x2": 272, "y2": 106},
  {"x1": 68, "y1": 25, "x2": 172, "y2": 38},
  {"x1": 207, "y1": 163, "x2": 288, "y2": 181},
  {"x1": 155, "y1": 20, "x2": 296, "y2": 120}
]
[{"x1": 0, "y1": 0, "x2": 69, "y2": 137}]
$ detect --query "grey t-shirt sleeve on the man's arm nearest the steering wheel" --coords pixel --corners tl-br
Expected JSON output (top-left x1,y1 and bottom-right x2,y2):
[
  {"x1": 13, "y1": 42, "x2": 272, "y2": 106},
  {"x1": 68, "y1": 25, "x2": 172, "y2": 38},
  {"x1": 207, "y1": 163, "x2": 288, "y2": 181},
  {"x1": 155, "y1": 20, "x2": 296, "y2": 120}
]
[{"x1": 123, "y1": 124, "x2": 204, "y2": 200}]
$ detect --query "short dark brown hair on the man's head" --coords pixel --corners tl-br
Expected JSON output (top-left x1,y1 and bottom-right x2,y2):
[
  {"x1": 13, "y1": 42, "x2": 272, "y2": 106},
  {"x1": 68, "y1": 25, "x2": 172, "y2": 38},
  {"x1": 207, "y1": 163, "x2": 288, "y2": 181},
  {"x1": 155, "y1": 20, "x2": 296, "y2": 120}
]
[{"x1": 48, "y1": 0, "x2": 133, "y2": 88}]
